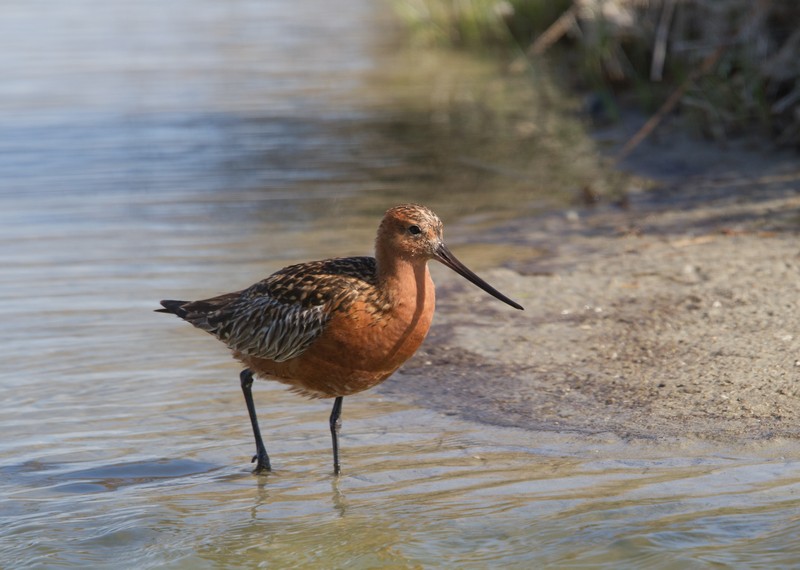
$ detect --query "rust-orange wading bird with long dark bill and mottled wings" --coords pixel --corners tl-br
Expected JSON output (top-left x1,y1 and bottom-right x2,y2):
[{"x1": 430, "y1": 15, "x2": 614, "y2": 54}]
[{"x1": 156, "y1": 204, "x2": 523, "y2": 475}]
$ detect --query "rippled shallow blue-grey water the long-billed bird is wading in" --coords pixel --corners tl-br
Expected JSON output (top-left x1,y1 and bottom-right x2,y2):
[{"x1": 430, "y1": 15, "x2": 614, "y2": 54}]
[{"x1": 0, "y1": 0, "x2": 800, "y2": 568}]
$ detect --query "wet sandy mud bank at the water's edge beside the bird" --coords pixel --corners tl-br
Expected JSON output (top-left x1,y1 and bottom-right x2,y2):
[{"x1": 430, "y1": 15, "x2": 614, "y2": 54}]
[{"x1": 383, "y1": 133, "x2": 800, "y2": 439}]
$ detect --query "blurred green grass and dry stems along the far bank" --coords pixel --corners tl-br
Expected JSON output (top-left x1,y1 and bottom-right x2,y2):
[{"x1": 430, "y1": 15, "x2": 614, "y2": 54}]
[{"x1": 394, "y1": 0, "x2": 800, "y2": 146}]
